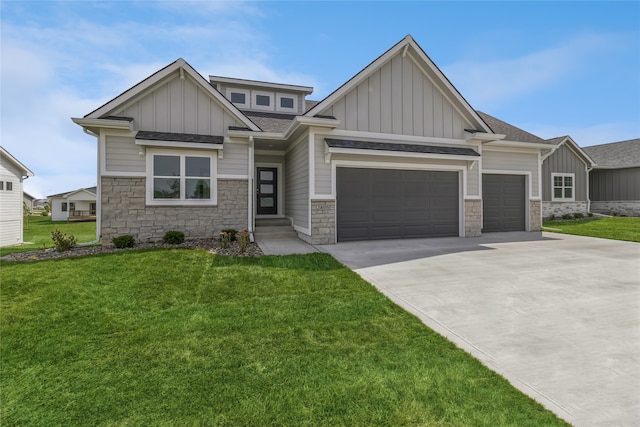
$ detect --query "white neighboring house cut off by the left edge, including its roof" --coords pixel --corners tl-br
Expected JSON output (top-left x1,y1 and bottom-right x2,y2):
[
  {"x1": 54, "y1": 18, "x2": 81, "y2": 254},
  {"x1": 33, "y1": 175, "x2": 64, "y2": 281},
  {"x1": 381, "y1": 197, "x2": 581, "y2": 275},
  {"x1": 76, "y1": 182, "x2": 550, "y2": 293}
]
[{"x1": 0, "y1": 147, "x2": 33, "y2": 246}]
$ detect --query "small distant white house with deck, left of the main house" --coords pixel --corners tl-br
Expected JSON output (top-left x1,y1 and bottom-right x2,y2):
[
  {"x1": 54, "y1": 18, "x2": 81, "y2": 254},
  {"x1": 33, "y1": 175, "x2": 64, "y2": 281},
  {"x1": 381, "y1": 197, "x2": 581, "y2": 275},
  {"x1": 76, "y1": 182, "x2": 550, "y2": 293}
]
[{"x1": 47, "y1": 187, "x2": 97, "y2": 221}]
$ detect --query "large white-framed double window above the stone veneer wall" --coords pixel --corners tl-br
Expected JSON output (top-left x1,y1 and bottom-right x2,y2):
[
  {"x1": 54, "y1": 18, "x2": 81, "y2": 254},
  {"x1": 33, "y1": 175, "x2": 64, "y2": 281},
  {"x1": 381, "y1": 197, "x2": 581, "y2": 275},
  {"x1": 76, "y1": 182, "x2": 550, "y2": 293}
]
[{"x1": 147, "y1": 150, "x2": 216, "y2": 205}]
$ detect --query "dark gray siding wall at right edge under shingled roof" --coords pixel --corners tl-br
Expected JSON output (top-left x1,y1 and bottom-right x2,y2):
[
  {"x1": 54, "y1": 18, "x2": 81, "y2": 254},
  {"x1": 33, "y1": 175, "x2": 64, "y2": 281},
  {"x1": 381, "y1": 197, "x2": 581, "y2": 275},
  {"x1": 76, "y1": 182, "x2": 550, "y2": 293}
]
[{"x1": 589, "y1": 168, "x2": 640, "y2": 201}]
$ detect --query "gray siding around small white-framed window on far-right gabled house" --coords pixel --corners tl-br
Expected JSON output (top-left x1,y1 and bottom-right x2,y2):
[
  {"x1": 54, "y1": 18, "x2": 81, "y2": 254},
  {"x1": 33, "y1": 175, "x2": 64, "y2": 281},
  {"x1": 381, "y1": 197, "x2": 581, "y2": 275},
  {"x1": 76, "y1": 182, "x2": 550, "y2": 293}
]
[{"x1": 542, "y1": 144, "x2": 587, "y2": 202}]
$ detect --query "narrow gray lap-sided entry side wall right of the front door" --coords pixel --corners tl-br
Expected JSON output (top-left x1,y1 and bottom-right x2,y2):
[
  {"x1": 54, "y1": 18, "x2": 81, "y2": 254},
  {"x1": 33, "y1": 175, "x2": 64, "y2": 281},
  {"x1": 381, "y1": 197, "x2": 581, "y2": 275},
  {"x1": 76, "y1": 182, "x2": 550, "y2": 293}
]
[{"x1": 284, "y1": 137, "x2": 309, "y2": 229}]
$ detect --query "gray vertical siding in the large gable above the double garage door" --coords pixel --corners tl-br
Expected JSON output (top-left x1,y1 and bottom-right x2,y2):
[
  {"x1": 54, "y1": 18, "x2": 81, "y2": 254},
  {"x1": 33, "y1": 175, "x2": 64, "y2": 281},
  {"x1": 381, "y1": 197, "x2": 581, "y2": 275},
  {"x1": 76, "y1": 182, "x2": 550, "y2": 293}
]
[{"x1": 322, "y1": 55, "x2": 469, "y2": 138}]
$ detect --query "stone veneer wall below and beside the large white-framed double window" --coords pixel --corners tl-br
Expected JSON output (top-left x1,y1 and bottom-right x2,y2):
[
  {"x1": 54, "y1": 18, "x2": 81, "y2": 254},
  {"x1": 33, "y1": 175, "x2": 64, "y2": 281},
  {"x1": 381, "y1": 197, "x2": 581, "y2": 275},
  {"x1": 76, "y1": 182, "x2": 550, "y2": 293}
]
[{"x1": 100, "y1": 177, "x2": 248, "y2": 246}]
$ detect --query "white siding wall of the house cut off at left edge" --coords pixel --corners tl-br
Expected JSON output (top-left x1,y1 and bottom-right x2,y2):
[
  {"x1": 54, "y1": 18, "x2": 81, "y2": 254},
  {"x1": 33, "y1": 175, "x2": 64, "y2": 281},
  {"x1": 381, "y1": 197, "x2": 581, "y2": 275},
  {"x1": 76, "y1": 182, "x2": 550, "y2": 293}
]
[{"x1": 0, "y1": 157, "x2": 23, "y2": 246}]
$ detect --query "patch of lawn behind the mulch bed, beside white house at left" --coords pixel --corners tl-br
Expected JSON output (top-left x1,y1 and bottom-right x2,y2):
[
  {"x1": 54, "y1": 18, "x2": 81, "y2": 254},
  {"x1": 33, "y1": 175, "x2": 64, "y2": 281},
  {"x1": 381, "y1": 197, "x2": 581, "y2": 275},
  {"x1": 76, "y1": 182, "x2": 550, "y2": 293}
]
[{"x1": 0, "y1": 216, "x2": 96, "y2": 256}]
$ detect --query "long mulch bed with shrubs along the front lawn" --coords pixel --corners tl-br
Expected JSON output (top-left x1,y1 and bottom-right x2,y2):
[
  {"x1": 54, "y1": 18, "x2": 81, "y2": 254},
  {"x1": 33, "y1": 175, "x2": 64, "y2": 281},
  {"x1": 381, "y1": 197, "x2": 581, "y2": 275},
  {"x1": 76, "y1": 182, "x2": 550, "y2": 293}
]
[{"x1": 2, "y1": 239, "x2": 263, "y2": 262}]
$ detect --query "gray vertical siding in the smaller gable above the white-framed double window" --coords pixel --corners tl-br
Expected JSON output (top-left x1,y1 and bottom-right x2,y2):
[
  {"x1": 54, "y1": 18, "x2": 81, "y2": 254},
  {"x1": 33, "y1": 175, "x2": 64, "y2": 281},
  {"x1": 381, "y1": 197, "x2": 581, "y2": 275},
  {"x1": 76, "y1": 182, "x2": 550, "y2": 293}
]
[{"x1": 112, "y1": 74, "x2": 242, "y2": 135}]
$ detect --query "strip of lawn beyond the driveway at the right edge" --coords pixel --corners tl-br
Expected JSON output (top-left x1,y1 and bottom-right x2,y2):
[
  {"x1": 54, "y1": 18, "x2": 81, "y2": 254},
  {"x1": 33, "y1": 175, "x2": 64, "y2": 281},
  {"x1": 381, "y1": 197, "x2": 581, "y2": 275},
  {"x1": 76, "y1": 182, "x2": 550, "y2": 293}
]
[{"x1": 542, "y1": 217, "x2": 640, "y2": 242}]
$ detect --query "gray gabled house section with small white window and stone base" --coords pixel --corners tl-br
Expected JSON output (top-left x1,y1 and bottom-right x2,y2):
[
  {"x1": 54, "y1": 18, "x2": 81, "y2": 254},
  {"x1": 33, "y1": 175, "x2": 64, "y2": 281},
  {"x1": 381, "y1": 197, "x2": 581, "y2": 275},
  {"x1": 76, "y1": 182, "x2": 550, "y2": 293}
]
[{"x1": 542, "y1": 136, "x2": 594, "y2": 218}]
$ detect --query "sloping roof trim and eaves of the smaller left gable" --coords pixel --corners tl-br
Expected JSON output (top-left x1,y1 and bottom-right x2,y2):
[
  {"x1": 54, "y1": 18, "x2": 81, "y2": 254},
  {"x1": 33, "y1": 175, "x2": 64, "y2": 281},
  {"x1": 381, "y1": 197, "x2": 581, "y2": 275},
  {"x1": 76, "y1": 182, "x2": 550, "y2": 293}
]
[{"x1": 79, "y1": 58, "x2": 260, "y2": 131}]
